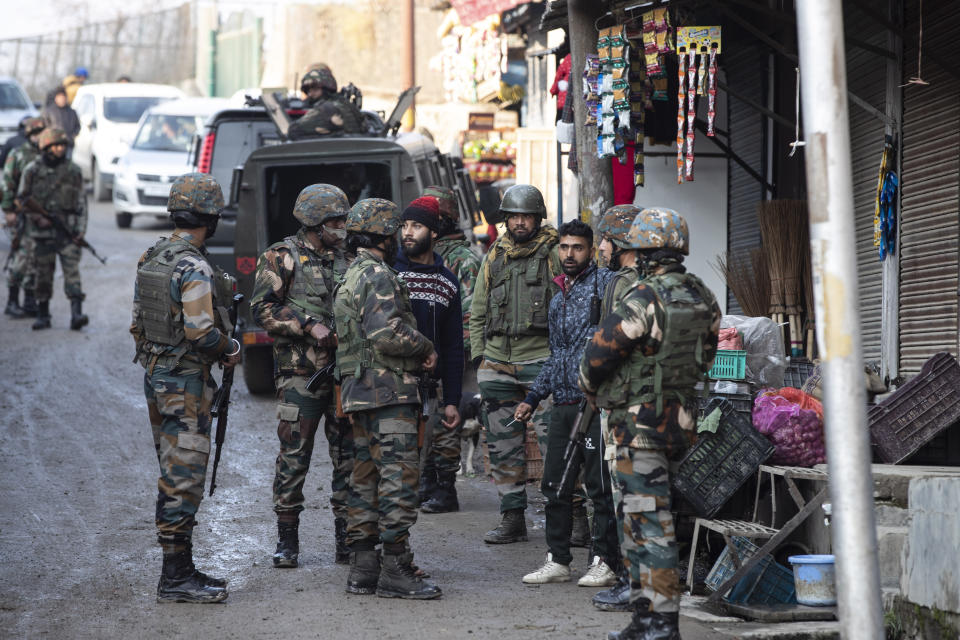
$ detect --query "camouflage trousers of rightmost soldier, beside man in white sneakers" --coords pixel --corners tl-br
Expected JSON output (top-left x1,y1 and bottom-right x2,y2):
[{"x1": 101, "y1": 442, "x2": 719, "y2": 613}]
[{"x1": 611, "y1": 446, "x2": 680, "y2": 613}]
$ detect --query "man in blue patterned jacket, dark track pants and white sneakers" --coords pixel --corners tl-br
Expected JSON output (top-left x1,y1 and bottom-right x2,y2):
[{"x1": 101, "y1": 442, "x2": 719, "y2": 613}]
[{"x1": 514, "y1": 220, "x2": 619, "y2": 587}]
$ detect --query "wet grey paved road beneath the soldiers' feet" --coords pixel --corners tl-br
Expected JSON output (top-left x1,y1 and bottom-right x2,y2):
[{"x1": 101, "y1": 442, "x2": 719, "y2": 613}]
[{"x1": 0, "y1": 204, "x2": 808, "y2": 640}]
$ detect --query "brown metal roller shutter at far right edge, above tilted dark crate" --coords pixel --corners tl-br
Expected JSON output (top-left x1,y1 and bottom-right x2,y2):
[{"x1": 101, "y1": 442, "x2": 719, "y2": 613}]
[{"x1": 900, "y1": 0, "x2": 960, "y2": 376}]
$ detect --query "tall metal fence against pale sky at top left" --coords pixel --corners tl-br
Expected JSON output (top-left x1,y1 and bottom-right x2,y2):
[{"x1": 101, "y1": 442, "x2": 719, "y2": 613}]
[{"x1": 0, "y1": 3, "x2": 197, "y2": 102}]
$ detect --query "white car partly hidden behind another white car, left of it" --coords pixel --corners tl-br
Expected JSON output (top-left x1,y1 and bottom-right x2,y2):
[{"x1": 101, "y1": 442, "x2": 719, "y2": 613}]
[{"x1": 73, "y1": 82, "x2": 186, "y2": 200}]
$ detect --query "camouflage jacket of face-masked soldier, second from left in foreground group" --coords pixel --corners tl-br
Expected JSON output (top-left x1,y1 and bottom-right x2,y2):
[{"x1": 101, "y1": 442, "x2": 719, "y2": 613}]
[{"x1": 250, "y1": 229, "x2": 347, "y2": 376}]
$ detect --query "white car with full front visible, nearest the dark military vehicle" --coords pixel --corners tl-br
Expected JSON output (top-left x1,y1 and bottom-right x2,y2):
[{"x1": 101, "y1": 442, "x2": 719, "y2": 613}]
[{"x1": 113, "y1": 98, "x2": 230, "y2": 229}]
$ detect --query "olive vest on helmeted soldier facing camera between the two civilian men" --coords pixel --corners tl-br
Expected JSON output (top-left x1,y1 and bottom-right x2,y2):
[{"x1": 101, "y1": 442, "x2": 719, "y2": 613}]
[{"x1": 486, "y1": 242, "x2": 553, "y2": 337}]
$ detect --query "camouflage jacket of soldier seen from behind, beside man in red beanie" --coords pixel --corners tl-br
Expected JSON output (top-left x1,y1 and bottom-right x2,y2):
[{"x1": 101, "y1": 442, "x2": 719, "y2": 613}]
[{"x1": 333, "y1": 249, "x2": 433, "y2": 413}]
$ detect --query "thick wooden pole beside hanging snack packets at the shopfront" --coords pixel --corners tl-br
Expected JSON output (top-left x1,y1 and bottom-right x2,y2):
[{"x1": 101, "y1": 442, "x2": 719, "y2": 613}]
[{"x1": 567, "y1": 0, "x2": 613, "y2": 226}]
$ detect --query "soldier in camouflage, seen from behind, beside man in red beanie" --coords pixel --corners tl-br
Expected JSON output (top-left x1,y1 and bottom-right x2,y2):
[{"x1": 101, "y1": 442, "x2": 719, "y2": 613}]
[{"x1": 333, "y1": 198, "x2": 441, "y2": 599}]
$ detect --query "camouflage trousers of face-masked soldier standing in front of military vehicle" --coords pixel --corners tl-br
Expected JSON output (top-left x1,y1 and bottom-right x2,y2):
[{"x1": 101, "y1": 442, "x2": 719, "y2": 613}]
[{"x1": 273, "y1": 376, "x2": 354, "y2": 520}]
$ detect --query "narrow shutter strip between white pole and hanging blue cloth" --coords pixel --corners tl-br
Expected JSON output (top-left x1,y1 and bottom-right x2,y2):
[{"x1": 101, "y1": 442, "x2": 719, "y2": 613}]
[{"x1": 844, "y1": 3, "x2": 887, "y2": 364}]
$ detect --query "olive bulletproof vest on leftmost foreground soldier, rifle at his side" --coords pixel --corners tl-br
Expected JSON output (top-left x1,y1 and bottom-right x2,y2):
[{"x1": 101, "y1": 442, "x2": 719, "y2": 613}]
[{"x1": 137, "y1": 238, "x2": 234, "y2": 351}]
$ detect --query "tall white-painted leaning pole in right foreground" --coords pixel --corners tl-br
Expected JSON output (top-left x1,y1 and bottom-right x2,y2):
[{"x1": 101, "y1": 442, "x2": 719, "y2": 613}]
[{"x1": 797, "y1": 0, "x2": 884, "y2": 640}]
